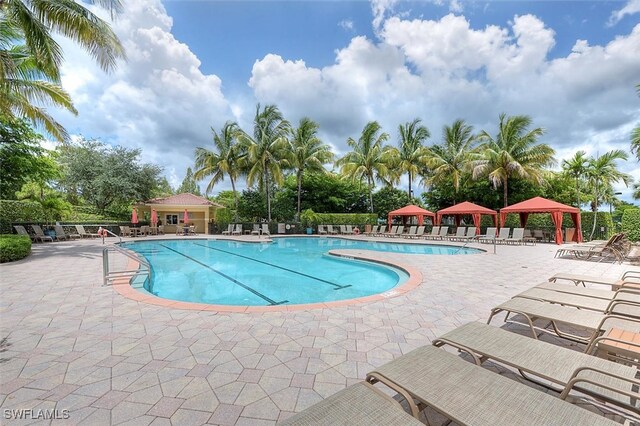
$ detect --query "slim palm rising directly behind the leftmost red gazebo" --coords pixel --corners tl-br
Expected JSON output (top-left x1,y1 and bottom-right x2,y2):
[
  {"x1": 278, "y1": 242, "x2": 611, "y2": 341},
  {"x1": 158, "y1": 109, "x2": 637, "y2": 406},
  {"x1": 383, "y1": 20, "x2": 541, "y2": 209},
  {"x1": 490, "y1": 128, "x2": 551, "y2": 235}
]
[{"x1": 390, "y1": 118, "x2": 431, "y2": 199}]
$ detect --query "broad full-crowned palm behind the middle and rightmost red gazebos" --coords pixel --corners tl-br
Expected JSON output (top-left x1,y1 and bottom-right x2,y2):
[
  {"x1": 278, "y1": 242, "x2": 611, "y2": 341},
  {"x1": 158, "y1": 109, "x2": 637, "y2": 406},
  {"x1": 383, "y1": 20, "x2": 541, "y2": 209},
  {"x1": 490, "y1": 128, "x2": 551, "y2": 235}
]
[{"x1": 473, "y1": 113, "x2": 555, "y2": 207}]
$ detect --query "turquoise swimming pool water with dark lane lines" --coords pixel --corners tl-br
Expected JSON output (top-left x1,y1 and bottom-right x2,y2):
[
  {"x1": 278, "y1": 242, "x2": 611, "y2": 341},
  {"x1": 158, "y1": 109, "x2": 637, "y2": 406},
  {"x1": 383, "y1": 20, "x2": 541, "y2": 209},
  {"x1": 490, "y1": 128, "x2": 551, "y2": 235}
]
[{"x1": 123, "y1": 238, "x2": 478, "y2": 306}]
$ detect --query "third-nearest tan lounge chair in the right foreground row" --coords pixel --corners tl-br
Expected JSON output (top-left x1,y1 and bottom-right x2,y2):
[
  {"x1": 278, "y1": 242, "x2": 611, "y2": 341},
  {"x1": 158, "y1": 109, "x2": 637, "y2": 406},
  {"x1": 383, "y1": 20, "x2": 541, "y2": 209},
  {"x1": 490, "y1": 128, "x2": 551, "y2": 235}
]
[{"x1": 432, "y1": 322, "x2": 640, "y2": 410}]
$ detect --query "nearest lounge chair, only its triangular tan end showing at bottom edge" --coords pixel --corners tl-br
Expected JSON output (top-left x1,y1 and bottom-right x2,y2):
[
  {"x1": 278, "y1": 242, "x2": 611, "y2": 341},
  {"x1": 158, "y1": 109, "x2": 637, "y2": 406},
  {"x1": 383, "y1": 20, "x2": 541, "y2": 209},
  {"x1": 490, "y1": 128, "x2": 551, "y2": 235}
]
[{"x1": 279, "y1": 382, "x2": 423, "y2": 426}]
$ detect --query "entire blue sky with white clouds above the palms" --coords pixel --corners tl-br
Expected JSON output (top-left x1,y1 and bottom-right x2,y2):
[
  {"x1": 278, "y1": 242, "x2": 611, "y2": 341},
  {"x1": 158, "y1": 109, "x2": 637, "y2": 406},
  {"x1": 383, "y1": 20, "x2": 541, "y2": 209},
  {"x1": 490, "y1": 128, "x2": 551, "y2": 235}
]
[{"x1": 52, "y1": 0, "x2": 640, "y2": 202}]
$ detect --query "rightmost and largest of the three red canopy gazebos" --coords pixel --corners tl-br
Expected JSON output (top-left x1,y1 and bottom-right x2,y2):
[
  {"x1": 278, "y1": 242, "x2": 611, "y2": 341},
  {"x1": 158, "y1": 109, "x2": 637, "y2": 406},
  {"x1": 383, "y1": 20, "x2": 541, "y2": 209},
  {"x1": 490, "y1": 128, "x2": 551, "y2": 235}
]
[{"x1": 500, "y1": 197, "x2": 582, "y2": 244}]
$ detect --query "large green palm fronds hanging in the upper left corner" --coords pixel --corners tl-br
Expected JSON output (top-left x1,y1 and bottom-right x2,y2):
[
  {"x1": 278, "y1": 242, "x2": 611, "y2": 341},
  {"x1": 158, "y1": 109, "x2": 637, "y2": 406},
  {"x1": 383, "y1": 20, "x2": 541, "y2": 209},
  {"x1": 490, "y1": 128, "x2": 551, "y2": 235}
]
[{"x1": 0, "y1": 0, "x2": 125, "y2": 140}]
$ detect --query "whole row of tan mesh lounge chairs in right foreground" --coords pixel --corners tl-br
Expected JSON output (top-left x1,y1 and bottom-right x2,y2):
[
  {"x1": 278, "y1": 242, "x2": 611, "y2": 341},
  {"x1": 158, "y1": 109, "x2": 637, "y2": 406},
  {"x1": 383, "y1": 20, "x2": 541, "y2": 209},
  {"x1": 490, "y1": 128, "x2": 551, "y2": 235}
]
[{"x1": 282, "y1": 271, "x2": 640, "y2": 426}]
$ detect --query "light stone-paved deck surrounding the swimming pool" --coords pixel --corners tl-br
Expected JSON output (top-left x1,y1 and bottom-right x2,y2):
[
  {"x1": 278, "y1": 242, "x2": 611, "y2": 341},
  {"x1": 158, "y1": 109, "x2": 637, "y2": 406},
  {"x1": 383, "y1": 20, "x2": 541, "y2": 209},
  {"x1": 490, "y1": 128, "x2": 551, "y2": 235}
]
[{"x1": 0, "y1": 236, "x2": 637, "y2": 425}]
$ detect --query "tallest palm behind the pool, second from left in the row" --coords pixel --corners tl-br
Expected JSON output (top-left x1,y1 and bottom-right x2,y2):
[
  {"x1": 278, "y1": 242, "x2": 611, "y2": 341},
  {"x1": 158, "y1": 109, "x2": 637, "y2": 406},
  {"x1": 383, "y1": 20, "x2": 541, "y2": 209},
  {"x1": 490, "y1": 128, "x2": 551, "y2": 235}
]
[{"x1": 238, "y1": 104, "x2": 291, "y2": 222}]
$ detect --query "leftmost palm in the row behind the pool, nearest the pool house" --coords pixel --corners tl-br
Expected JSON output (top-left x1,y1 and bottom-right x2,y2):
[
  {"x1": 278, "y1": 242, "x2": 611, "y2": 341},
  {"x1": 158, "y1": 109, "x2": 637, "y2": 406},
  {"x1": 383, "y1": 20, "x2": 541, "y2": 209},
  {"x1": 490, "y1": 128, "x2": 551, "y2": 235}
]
[{"x1": 194, "y1": 121, "x2": 243, "y2": 215}]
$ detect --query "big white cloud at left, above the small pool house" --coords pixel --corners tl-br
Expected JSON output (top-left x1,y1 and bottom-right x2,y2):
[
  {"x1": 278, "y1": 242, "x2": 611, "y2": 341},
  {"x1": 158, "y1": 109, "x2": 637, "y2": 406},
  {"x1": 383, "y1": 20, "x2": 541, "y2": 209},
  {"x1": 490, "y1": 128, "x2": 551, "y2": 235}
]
[{"x1": 53, "y1": 0, "x2": 232, "y2": 186}]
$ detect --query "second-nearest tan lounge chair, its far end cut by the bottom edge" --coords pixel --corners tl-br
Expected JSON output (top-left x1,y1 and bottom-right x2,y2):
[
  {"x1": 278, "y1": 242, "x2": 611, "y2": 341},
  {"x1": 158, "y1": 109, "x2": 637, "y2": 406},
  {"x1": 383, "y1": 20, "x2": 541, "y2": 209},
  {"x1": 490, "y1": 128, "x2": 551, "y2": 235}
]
[{"x1": 364, "y1": 345, "x2": 619, "y2": 426}]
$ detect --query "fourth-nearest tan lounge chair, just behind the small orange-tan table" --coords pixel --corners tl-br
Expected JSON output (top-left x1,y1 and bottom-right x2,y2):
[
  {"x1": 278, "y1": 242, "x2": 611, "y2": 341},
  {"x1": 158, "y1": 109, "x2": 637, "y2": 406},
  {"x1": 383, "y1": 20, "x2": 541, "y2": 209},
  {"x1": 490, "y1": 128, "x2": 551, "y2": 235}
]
[{"x1": 487, "y1": 297, "x2": 640, "y2": 345}]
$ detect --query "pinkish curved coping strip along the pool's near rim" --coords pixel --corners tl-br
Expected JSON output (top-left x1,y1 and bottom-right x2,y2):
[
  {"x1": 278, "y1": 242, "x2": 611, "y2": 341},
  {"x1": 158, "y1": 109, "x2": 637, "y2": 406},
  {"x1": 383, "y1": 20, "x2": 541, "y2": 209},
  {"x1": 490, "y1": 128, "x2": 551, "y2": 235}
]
[{"x1": 111, "y1": 245, "x2": 422, "y2": 313}]
